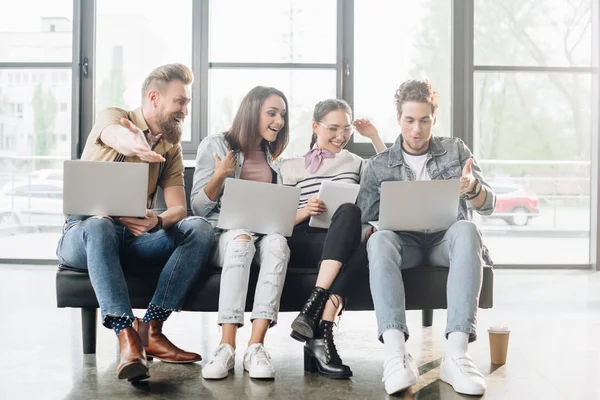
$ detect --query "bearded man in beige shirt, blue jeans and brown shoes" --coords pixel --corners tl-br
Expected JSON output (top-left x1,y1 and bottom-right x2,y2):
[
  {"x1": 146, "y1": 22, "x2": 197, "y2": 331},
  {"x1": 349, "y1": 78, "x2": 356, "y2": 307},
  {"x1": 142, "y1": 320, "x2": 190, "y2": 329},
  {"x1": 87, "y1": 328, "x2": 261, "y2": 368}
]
[{"x1": 57, "y1": 64, "x2": 214, "y2": 381}]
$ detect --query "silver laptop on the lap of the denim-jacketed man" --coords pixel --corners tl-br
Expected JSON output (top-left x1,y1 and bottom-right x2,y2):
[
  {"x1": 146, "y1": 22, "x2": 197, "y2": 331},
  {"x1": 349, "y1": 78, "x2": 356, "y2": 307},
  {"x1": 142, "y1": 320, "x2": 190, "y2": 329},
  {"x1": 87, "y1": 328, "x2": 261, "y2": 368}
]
[{"x1": 369, "y1": 179, "x2": 460, "y2": 231}]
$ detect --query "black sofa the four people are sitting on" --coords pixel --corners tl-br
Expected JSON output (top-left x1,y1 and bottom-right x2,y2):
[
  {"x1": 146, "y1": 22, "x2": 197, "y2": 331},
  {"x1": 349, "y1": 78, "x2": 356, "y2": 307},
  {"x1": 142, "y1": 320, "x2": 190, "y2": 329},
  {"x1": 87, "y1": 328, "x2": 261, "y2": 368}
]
[{"x1": 56, "y1": 168, "x2": 494, "y2": 354}]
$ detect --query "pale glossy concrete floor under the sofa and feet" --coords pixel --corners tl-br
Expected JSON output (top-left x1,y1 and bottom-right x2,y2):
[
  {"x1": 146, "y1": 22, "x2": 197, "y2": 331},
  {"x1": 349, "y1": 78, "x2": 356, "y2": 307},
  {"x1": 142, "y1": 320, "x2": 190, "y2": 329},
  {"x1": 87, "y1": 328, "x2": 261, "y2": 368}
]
[{"x1": 0, "y1": 265, "x2": 600, "y2": 400}]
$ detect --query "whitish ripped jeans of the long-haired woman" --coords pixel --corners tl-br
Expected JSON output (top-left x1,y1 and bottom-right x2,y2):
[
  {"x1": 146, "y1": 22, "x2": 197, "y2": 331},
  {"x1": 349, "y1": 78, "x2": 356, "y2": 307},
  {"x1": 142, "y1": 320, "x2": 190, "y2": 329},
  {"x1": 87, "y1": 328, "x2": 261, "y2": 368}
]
[{"x1": 213, "y1": 229, "x2": 290, "y2": 327}]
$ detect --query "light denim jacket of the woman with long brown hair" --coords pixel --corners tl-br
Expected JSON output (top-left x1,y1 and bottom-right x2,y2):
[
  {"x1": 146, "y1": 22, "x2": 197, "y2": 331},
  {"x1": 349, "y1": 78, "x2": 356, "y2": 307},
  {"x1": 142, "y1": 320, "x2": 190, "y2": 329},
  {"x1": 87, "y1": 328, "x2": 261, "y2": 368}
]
[{"x1": 190, "y1": 133, "x2": 279, "y2": 227}]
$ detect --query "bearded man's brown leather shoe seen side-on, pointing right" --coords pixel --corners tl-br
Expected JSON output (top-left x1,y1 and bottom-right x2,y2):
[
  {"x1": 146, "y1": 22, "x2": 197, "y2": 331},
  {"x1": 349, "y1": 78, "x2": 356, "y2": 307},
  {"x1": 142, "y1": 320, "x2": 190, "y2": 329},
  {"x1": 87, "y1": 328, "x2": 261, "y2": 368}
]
[{"x1": 133, "y1": 318, "x2": 202, "y2": 364}]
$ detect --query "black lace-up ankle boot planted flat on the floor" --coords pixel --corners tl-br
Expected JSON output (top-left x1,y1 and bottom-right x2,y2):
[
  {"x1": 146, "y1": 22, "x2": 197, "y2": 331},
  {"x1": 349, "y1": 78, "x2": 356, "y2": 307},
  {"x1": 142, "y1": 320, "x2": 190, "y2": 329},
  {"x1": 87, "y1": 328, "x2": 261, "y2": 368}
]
[{"x1": 304, "y1": 321, "x2": 352, "y2": 379}]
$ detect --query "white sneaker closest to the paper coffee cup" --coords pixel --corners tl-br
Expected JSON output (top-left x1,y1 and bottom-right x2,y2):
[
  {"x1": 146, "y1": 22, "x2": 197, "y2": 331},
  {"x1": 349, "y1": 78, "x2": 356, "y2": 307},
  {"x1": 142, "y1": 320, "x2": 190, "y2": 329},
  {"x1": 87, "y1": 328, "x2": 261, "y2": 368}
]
[{"x1": 440, "y1": 354, "x2": 487, "y2": 396}]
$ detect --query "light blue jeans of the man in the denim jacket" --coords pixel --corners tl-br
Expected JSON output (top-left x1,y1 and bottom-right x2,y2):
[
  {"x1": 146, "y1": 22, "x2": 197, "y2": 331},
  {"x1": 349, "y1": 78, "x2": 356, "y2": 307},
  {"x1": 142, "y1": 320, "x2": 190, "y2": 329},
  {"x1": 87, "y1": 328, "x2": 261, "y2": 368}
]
[{"x1": 367, "y1": 221, "x2": 483, "y2": 341}]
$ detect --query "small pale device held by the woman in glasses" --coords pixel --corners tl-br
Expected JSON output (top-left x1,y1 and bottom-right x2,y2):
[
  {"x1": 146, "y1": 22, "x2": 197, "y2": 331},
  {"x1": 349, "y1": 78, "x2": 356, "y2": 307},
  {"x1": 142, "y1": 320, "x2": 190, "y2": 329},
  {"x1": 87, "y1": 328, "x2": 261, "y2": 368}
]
[{"x1": 308, "y1": 181, "x2": 360, "y2": 229}]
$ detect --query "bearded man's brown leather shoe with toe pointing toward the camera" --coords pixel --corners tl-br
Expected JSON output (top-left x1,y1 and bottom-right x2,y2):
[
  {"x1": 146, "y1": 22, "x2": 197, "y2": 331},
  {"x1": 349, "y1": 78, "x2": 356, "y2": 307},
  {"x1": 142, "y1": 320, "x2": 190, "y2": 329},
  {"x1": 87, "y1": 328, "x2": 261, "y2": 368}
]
[{"x1": 117, "y1": 327, "x2": 150, "y2": 381}]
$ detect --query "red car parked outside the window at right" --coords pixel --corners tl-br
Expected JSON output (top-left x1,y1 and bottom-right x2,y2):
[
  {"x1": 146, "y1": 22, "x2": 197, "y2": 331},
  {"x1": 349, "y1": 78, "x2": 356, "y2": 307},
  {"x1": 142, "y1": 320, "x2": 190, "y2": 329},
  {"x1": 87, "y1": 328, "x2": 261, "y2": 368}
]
[{"x1": 488, "y1": 184, "x2": 540, "y2": 226}]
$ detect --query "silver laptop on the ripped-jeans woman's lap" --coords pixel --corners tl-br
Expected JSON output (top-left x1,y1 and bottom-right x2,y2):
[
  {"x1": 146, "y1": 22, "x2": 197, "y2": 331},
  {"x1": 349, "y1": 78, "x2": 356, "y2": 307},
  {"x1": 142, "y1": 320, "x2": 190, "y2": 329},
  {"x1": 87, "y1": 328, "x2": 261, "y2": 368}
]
[{"x1": 217, "y1": 178, "x2": 300, "y2": 237}]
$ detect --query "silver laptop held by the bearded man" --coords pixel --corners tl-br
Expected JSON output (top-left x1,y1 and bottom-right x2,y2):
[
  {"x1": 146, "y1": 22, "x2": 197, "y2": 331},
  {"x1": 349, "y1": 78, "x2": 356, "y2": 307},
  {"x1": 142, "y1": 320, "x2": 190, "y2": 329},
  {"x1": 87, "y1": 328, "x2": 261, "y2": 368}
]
[{"x1": 63, "y1": 160, "x2": 148, "y2": 217}]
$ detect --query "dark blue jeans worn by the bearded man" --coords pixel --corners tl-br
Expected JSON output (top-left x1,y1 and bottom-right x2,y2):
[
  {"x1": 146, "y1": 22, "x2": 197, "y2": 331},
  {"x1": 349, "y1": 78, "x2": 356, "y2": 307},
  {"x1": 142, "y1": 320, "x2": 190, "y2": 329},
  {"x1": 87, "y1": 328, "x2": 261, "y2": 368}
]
[{"x1": 56, "y1": 217, "x2": 215, "y2": 326}]
